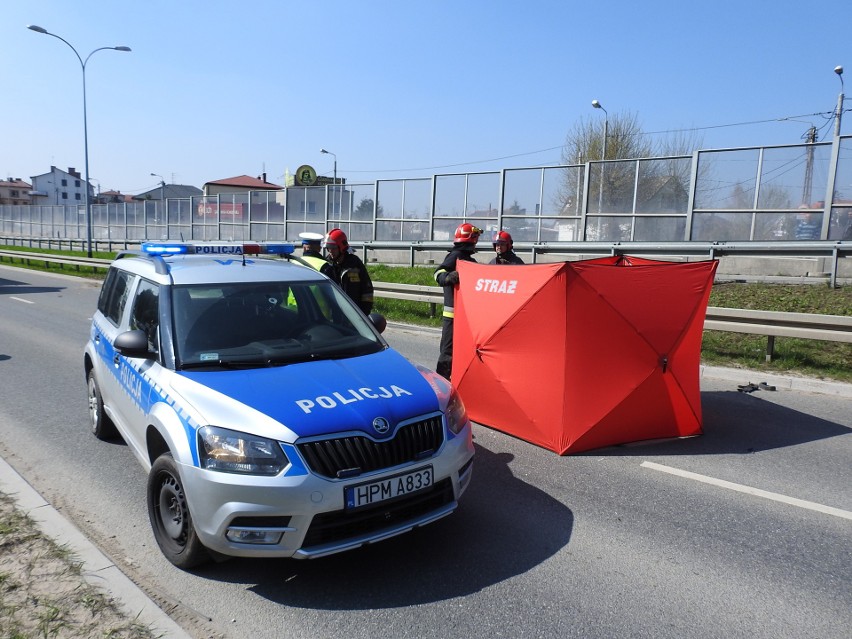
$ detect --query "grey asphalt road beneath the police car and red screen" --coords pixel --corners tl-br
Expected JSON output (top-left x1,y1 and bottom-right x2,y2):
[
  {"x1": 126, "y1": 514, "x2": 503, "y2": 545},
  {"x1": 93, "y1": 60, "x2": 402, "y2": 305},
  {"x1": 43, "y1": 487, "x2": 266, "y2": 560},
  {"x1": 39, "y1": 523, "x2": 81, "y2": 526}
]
[{"x1": 0, "y1": 266, "x2": 852, "y2": 639}]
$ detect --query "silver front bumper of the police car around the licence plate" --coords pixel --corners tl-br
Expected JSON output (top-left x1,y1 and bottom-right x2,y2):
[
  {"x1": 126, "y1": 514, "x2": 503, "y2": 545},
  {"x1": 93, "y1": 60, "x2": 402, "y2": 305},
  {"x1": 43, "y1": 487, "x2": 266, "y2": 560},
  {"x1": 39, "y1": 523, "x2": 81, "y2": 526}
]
[{"x1": 181, "y1": 423, "x2": 474, "y2": 559}]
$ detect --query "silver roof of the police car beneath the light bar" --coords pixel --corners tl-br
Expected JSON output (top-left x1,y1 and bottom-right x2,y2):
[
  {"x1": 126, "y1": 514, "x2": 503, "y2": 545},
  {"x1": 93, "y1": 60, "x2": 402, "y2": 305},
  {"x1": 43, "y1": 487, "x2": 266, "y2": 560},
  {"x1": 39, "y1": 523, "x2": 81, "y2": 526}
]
[{"x1": 112, "y1": 254, "x2": 327, "y2": 285}]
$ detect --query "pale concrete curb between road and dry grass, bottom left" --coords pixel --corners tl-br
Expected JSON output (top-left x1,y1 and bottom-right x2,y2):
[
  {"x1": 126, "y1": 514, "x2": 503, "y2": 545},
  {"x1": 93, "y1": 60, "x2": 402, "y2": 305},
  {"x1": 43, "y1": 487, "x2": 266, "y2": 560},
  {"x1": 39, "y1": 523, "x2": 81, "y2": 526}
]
[{"x1": 0, "y1": 458, "x2": 190, "y2": 639}]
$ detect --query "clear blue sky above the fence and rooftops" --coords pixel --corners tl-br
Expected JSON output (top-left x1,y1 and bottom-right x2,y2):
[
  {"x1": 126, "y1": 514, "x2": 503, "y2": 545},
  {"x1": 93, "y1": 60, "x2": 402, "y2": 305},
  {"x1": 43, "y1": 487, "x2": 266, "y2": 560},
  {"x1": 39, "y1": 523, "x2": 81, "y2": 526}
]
[{"x1": 0, "y1": 0, "x2": 852, "y2": 195}]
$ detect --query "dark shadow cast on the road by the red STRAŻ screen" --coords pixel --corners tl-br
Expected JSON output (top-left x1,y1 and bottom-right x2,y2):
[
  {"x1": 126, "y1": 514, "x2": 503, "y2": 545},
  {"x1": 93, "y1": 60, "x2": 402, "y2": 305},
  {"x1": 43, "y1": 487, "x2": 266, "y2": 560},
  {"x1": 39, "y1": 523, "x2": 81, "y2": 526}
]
[{"x1": 581, "y1": 391, "x2": 850, "y2": 455}]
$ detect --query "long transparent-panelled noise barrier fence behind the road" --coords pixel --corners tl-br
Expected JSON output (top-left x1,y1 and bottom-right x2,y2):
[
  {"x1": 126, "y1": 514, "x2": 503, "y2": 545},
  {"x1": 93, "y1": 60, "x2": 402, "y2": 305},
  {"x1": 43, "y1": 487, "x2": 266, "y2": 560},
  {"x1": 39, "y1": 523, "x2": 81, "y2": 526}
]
[{"x1": 0, "y1": 136, "x2": 852, "y2": 244}]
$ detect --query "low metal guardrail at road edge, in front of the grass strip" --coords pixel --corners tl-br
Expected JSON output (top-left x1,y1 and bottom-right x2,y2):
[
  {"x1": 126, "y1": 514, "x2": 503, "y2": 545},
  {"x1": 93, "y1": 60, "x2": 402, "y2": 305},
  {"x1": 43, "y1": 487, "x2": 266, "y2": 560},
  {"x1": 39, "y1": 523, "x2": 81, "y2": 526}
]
[{"x1": 0, "y1": 250, "x2": 852, "y2": 361}]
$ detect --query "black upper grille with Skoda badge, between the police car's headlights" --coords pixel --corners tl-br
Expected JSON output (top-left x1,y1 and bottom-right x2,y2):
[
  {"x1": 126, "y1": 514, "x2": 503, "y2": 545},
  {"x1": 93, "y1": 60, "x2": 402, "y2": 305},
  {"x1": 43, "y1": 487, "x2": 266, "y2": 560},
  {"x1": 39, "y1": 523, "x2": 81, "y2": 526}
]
[{"x1": 298, "y1": 415, "x2": 444, "y2": 478}]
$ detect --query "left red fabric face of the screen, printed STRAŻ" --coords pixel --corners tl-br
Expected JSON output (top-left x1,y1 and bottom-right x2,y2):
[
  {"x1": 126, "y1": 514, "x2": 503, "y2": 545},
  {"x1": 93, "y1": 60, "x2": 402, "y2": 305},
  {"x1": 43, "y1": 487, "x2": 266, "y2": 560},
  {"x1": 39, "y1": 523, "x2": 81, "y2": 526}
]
[{"x1": 453, "y1": 262, "x2": 566, "y2": 449}]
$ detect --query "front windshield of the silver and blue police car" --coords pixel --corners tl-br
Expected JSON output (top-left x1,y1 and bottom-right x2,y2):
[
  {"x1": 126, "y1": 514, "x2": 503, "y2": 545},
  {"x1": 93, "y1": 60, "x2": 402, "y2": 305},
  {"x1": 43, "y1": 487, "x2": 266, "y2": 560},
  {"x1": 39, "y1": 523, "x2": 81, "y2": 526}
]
[{"x1": 172, "y1": 281, "x2": 385, "y2": 369}]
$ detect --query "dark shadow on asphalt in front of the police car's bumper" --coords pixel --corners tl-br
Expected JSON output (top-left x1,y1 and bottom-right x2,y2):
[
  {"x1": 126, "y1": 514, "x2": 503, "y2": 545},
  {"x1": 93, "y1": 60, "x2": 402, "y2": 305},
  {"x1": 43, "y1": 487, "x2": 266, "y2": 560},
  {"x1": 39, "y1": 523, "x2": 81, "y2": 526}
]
[{"x1": 199, "y1": 446, "x2": 574, "y2": 610}]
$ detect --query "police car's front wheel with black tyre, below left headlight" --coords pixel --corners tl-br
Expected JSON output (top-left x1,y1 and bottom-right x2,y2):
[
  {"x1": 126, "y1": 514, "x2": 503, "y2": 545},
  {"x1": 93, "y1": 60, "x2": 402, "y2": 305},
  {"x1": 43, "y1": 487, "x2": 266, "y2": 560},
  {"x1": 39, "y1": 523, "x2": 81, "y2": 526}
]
[{"x1": 148, "y1": 453, "x2": 211, "y2": 568}]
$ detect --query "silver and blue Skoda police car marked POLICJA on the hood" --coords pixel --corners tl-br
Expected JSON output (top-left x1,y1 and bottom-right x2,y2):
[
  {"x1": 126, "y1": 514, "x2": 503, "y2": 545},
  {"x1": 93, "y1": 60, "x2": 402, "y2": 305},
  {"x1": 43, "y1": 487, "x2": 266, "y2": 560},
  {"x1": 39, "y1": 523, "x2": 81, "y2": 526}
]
[{"x1": 84, "y1": 243, "x2": 473, "y2": 568}]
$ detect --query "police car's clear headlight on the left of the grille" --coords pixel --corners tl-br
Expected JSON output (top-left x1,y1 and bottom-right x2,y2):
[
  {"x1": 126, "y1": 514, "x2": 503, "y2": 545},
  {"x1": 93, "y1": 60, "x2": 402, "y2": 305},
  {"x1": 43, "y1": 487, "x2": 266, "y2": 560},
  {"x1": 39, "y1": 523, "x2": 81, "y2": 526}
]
[{"x1": 198, "y1": 426, "x2": 290, "y2": 475}]
